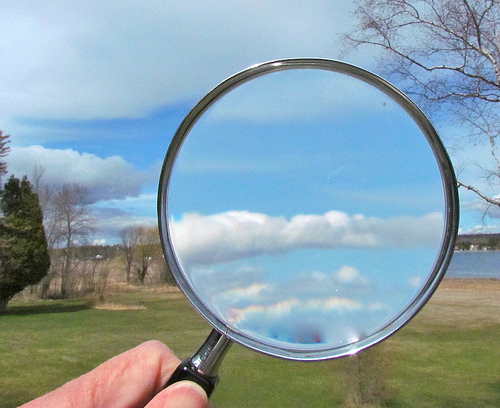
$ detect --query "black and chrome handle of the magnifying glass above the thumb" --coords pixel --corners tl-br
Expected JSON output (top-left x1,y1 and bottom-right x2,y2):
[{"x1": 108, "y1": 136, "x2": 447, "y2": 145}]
[{"x1": 165, "y1": 330, "x2": 232, "y2": 397}]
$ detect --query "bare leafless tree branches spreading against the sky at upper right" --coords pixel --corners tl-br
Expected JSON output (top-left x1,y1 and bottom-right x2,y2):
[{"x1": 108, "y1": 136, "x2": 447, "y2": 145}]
[{"x1": 344, "y1": 0, "x2": 500, "y2": 206}]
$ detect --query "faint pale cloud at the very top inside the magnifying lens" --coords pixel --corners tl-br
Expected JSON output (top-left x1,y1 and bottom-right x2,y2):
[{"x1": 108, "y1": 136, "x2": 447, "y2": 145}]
[{"x1": 210, "y1": 69, "x2": 396, "y2": 124}]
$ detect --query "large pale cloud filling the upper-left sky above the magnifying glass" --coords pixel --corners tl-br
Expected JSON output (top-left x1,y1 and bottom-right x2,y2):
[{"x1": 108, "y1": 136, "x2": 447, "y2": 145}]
[{"x1": 0, "y1": 0, "x2": 360, "y2": 127}]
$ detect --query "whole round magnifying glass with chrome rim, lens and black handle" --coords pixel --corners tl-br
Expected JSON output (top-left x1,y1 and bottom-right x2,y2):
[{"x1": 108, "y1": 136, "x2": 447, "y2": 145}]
[{"x1": 158, "y1": 59, "x2": 458, "y2": 395}]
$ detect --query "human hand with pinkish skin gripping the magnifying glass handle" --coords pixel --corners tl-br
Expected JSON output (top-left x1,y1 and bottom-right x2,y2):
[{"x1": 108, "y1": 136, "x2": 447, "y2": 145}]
[{"x1": 20, "y1": 341, "x2": 208, "y2": 408}]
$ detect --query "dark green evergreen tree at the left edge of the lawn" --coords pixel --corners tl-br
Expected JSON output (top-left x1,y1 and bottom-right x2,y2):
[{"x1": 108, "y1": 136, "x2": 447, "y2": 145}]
[{"x1": 0, "y1": 176, "x2": 50, "y2": 313}]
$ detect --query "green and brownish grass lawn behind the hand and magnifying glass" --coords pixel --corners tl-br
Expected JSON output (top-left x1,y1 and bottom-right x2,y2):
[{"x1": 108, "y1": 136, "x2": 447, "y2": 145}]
[{"x1": 0, "y1": 280, "x2": 500, "y2": 408}]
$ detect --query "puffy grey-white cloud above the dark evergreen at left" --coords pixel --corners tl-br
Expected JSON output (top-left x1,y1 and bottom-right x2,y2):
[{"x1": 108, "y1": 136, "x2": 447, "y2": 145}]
[{"x1": 6, "y1": 146, "x2": 145, "y2": 202}]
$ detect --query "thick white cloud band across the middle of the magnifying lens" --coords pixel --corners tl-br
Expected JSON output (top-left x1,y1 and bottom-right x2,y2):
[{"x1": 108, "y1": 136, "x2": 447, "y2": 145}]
[{"x1": 171, "y1": 211, "x2": 443, "y2": 266}]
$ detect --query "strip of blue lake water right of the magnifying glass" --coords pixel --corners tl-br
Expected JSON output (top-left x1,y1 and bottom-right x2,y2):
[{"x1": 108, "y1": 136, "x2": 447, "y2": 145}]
[{"x1": 445, "y1": 251, "x2": 500, "y2": 279}]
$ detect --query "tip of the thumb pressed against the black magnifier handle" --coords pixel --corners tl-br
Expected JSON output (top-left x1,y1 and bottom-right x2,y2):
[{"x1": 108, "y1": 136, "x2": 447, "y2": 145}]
[{"x1": 146, "y1": 381, "x2": 208, "y2": 408}]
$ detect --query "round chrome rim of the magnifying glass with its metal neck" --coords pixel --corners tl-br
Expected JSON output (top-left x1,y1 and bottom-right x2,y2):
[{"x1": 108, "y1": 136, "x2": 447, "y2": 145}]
[{"x1": 158, "y1": 58, "x2": 459, "y2": 382}]
